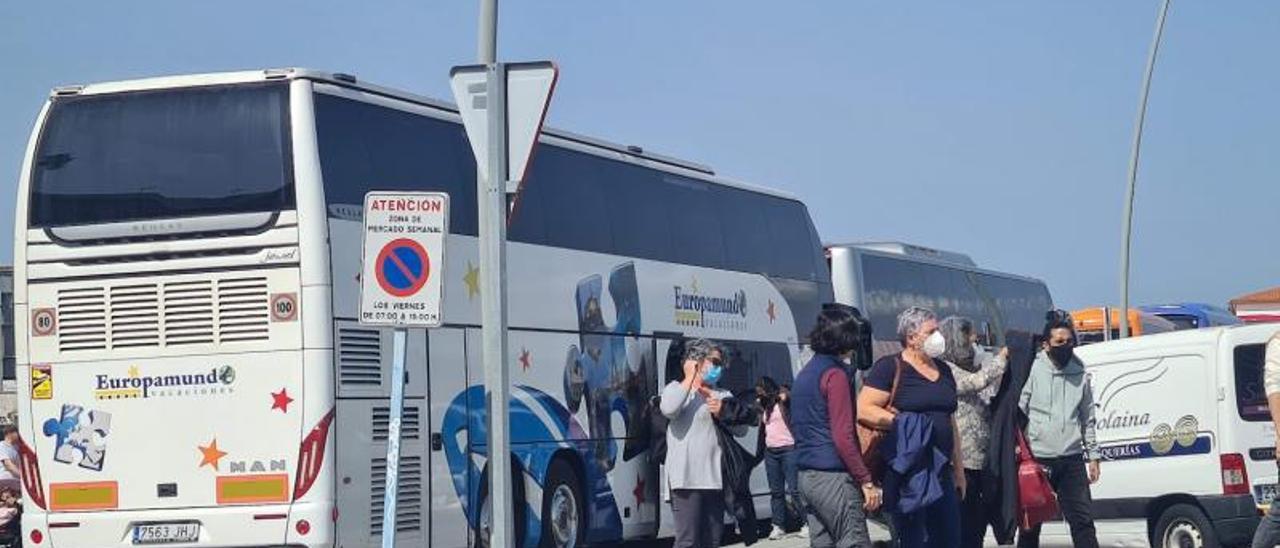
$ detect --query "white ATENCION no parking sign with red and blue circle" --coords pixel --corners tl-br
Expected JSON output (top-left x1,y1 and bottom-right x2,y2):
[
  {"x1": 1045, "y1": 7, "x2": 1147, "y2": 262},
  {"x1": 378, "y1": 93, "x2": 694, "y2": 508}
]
[{"x1": 360, "y1": 192, "x2": 449, "y2": 328}]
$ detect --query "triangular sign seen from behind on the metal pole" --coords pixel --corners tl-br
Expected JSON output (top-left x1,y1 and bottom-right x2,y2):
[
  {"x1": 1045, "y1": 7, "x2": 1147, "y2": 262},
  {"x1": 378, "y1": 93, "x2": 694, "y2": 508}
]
[{"x1": 449, "y1": 61, "x2": 559, "y2": 193}]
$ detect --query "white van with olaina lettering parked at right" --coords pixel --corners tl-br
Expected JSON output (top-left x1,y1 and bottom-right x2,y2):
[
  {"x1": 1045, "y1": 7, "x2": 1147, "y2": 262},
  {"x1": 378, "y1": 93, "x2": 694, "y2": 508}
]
[{"x1": 1044, "y1": 324, "x2": 1280, "y2": 547}]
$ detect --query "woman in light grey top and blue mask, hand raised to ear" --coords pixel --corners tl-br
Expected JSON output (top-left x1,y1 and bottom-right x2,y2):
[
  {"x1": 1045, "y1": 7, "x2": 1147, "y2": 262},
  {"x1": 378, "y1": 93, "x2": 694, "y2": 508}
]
[{"x1": 659, "y1": 339, "x2": 733, "y2": 548}]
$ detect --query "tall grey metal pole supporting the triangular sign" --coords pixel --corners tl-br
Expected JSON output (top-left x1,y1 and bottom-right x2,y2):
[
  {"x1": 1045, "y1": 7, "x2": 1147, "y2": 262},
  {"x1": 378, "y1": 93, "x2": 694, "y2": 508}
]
[{"x1": 476, "y1": 0, "x2": 516, "y2": 548}]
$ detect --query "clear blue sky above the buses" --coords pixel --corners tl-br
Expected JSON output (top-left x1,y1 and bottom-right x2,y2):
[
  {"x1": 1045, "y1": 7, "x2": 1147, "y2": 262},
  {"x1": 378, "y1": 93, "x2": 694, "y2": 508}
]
[{"x1": 0, "y1": 0, "x2": 1280, "y2": 306}]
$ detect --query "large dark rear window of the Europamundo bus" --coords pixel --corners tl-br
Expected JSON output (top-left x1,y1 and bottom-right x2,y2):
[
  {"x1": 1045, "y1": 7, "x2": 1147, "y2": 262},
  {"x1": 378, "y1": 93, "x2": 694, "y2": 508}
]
[{"x1": 29, "y1": 85, "x2": 294, "y2": 228}]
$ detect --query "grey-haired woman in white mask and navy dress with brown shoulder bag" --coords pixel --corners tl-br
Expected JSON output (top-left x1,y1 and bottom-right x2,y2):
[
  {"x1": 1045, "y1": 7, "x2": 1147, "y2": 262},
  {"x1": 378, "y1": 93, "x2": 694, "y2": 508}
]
[{"x1": 858, "y1": 307, "x2": 965, "y2": 548}]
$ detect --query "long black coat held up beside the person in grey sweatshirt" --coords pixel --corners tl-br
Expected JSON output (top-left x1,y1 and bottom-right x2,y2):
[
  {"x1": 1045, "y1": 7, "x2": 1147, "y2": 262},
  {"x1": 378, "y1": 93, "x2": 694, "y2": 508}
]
[{"x1": 983, "y1": 330, "x2": 1039, "y2": 545}]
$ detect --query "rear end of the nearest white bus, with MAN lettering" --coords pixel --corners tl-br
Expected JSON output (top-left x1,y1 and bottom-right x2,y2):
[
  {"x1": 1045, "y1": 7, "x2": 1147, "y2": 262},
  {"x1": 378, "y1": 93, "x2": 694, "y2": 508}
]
[{"x1": 14, "y1": 72, "x2": 337, "y2": 547}]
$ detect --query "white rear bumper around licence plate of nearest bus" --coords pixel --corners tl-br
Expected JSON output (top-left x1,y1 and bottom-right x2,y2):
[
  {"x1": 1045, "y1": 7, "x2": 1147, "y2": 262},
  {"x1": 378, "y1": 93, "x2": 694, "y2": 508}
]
[{"x1": 22, "y1": 501, "x2": 334, "y2": 548}]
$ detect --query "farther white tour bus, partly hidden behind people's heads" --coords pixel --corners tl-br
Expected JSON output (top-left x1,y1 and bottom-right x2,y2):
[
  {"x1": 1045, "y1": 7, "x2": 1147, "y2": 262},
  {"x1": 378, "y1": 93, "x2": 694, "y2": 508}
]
[{"x1": 827, "y1": 242, "x2": 1053, "y2": 359}]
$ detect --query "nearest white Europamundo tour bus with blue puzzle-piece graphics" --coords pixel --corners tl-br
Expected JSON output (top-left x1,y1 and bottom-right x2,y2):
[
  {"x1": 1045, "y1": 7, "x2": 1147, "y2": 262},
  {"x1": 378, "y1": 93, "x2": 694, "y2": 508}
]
[{"x1": 14, "y1": 69, "x2": 832, "y2": 547}]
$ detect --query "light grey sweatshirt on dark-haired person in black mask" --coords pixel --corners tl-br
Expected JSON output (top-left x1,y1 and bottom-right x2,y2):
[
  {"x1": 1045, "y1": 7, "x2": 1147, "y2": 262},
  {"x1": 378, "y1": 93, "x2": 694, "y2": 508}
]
[{"x1": 1018, "y1": 351, "x2": 1102, "y2": 461}]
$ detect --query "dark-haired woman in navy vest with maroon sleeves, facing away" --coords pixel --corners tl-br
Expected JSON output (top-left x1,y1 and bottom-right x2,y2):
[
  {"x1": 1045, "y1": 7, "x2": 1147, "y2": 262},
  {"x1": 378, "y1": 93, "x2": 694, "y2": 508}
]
[{"x1": 791, "y1": 305, "x2": 881, "y2": 548}]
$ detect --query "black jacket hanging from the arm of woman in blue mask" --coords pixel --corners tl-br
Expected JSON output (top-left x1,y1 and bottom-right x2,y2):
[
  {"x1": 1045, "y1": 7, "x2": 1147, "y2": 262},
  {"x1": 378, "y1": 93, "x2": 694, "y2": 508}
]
[{"x1": 716, "y1": 398, "x2": 764, "y2": 545}]
